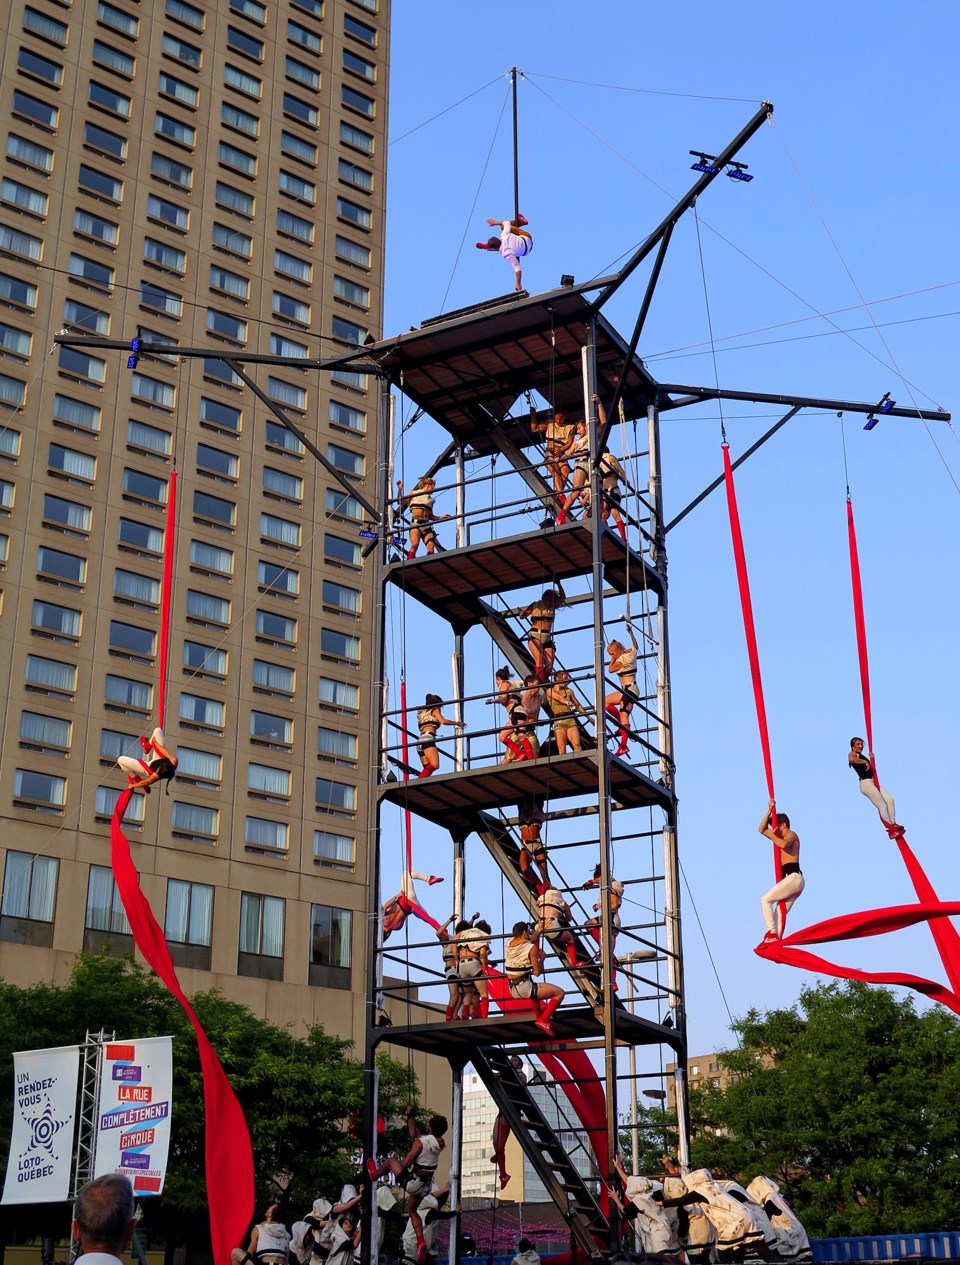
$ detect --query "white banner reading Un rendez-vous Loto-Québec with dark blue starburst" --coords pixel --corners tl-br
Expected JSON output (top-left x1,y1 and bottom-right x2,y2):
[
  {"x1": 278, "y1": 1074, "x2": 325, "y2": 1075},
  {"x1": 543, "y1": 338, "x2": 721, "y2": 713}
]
[{"x1": 3, "y1": 1045, "x2": 80, "y2": 1203}]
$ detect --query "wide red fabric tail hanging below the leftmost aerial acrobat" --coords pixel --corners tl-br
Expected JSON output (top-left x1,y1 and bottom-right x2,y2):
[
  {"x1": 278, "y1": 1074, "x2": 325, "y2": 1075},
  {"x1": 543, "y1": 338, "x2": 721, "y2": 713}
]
[{"x1": 110, "y1": 791, "x2": 254, "y2": 1265}]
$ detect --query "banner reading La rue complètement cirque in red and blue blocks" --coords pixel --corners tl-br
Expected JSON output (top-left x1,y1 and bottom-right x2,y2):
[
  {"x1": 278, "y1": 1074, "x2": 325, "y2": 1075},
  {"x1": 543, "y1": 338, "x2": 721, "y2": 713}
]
[{"x1": 94, "y1": 1036, "x2": 173, "y2": 1195}]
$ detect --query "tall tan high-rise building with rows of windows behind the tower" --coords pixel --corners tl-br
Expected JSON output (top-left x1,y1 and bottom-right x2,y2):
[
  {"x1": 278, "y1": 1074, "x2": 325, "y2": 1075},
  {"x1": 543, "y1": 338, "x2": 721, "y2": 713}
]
[{"x1": 0, "y1": 0, "x2": 390, "y2": 1045}]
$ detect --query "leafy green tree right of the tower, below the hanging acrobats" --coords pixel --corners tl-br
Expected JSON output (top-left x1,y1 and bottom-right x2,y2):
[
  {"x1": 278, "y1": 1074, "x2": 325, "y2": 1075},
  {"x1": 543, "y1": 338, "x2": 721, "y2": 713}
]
[{"x1": 691, "y1": 983, "x2": 960, "y2": 1237}]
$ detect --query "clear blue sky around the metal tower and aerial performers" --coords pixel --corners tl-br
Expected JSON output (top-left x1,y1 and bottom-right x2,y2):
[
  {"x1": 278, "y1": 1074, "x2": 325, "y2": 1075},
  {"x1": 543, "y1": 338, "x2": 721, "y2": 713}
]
[{"x1": 385, "y1": 0, "x2": 960, "y2": 1054}]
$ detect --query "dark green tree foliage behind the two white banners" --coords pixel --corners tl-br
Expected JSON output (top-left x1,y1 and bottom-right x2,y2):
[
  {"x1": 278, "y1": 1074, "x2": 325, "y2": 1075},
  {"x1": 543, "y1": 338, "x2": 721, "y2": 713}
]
[{"x1": 0, "y1": 955, "x2": 419, "y2": 1259}]
